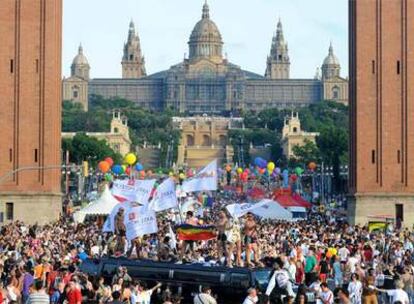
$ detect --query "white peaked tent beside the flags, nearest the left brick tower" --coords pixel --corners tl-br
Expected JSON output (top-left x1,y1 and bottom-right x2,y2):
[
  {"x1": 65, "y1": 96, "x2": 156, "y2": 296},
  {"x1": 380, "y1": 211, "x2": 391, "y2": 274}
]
[{"x1": 73, "y1": 186, "x2": 119, "y2": 223}]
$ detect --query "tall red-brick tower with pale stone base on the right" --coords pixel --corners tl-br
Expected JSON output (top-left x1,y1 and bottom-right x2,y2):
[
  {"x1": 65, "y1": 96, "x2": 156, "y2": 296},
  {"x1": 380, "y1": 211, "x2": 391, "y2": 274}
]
[{"x1": 349, "y1": 0, "x2": 414, "y2": 226}]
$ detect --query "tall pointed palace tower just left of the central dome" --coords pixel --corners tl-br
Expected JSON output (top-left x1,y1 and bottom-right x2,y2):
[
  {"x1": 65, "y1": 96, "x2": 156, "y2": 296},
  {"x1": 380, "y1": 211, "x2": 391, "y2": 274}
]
[{"x1": 121, "y1": 21, "x2": 147, "y2": 78}]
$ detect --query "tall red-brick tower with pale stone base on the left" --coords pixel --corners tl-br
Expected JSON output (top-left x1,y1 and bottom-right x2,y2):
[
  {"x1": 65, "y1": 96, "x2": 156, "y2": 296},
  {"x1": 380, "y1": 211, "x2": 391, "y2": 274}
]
[{"x1": 0, "y1": 0, "x2": 62, "y2": 223}]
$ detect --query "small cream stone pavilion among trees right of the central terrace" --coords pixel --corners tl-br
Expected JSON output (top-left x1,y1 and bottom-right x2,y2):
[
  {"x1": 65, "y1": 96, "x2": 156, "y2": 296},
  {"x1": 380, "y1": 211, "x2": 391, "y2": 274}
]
[{"x1": 282, "y1": 112, "x2": 319, "y2": 159}]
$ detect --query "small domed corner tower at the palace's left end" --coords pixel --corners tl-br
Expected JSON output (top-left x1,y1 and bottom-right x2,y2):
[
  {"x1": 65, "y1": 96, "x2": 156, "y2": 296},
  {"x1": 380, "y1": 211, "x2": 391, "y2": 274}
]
[{"x1": 62, "y1": 45, "x2": 90, "y2": 111}]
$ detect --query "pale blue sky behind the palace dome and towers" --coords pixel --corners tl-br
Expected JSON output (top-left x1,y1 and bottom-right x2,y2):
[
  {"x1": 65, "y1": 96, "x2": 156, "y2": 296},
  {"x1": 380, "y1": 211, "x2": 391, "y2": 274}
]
[{"x1": 62, "y1": 0, "x2": 348, "y2": 78}]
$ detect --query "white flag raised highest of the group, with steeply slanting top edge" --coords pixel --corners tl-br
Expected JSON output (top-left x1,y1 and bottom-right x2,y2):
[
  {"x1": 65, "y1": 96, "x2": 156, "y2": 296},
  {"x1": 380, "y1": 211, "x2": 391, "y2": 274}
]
[{"x1": 183, "y1": 159, "x2": 217, "y2": 192}]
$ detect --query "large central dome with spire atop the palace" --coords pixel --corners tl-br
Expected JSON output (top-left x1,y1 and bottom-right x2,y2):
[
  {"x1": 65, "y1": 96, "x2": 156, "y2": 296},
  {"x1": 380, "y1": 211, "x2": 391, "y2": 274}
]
[{"x1": 188, "y1": 3, "x2": 223, "y2": 61}]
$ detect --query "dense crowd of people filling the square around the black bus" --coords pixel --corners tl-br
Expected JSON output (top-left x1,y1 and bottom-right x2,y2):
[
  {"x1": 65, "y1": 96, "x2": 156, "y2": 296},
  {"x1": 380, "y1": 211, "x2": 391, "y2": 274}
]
[{"x1": 0, "y1": 188, "x2": 414, "y2": 304}]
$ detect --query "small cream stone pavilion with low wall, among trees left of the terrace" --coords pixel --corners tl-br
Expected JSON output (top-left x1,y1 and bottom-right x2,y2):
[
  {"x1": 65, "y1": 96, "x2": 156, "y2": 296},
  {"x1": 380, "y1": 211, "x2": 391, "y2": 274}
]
[{"x1": 62, "y1": 111, "x2": 132, "y2": 156}]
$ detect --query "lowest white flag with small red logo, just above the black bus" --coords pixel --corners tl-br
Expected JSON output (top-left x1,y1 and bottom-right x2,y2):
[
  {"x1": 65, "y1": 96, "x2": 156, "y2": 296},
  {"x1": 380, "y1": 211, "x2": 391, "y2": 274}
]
[{"x1": 125, "y1": 206, "x2": 158, "y2": 241}]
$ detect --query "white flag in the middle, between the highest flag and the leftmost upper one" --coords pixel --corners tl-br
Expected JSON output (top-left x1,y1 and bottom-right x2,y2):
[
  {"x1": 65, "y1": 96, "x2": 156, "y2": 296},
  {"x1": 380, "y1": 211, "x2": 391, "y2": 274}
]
[{"x1": 149, "y1": 178, "x2": 178, "y2": 212}]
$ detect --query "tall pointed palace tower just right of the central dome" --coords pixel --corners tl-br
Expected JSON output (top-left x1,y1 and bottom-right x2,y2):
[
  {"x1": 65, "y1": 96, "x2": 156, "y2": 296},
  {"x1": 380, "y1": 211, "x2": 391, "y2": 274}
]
[{"x1": 265, "y1": 19, "x2": 290, "y2": 79}]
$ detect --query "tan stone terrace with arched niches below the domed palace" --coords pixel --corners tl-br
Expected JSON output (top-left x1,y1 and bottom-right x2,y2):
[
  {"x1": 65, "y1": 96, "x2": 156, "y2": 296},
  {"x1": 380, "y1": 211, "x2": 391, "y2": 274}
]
[{"x1": 173, "y1": 115, "x2": 243, "y2": 168}]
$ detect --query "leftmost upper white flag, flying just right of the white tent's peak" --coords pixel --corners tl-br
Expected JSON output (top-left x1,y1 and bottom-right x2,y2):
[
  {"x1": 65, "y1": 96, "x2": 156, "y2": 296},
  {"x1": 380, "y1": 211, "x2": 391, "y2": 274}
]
[{"x1": 112, "y1": 179, "x2": 155, "y2": 206}]
